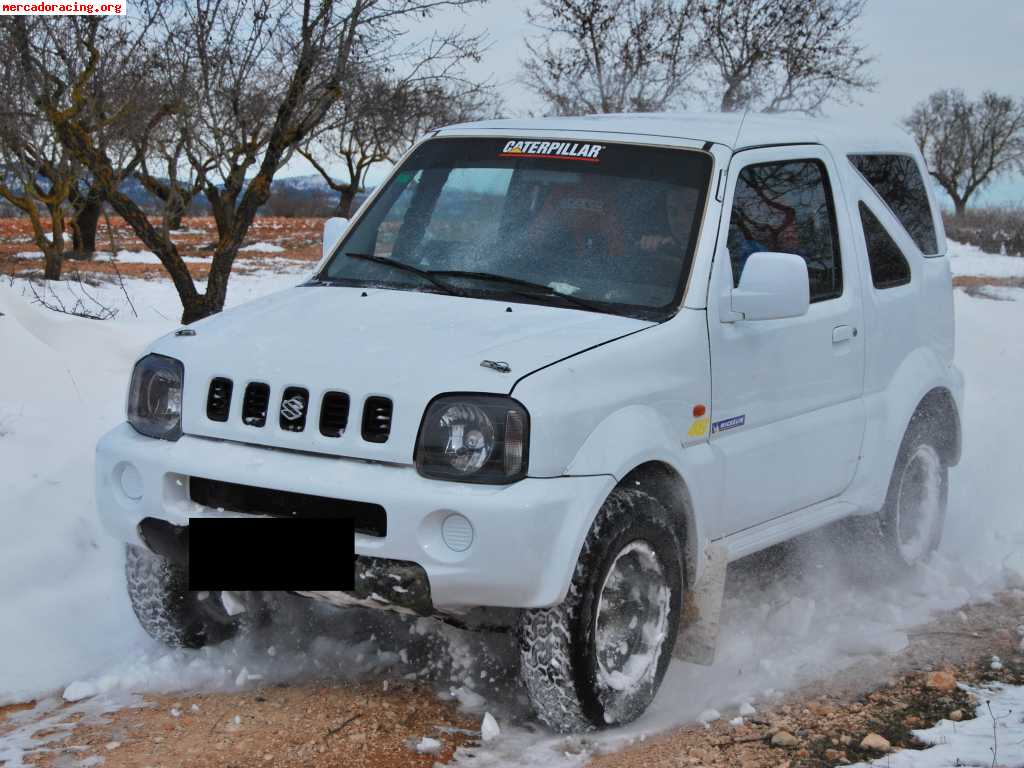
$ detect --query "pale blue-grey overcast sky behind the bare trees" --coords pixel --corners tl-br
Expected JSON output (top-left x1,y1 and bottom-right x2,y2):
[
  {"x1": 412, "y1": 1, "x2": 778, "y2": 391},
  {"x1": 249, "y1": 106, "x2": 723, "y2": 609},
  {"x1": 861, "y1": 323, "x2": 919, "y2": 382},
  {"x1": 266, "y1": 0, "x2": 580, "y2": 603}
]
[{"x1": 286, "y1": 0, "x2": 1024, "y2": 204}]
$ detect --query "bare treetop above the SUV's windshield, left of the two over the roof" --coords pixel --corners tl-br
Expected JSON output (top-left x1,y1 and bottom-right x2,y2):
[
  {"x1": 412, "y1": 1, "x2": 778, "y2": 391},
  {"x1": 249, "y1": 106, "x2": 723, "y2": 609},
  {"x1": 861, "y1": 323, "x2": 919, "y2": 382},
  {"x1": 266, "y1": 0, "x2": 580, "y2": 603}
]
[{"x1": 521, "y1": 0, "x2": 695, "y2": 115}]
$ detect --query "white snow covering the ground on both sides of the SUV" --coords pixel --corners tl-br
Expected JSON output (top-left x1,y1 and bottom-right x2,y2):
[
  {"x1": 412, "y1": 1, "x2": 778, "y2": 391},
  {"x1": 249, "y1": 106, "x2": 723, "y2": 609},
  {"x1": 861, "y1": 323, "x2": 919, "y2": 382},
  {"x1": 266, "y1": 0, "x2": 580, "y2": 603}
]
[{"x1": 0, "y1": 244, "x2": 1024, "y2": 766}]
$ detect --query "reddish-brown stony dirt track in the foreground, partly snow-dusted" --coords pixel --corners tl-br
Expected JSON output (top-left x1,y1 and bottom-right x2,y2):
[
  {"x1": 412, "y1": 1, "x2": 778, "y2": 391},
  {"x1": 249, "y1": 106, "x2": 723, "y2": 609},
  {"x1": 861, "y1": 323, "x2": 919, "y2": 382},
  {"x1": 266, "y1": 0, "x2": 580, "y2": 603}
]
[{"x1": 0, "y1": 591, "x2": 1024, "y2": 768}]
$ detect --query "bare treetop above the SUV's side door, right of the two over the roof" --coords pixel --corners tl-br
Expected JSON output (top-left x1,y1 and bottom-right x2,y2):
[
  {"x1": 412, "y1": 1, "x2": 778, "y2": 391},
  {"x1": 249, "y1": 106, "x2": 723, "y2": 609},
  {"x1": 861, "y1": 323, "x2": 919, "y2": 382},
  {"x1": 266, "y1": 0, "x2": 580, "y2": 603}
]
[{"x1": 698, "y1": 0, "x2": 874, "y2": 115}]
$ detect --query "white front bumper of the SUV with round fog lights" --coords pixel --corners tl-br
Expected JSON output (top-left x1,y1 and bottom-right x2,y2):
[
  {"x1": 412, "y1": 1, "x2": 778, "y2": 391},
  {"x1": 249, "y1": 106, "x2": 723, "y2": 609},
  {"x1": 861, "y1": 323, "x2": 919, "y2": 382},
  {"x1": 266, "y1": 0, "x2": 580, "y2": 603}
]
[{"x1": 96, "y1": 424, "x2": 614, "y2": 610}]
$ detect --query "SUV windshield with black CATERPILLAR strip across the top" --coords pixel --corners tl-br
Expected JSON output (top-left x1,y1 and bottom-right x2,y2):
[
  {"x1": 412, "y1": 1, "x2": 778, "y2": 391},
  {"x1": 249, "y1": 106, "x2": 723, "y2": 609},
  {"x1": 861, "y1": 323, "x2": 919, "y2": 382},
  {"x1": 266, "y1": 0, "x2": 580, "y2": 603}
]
[{"x1": 318, "y1": 137, "x2": 712, "y2": 318}]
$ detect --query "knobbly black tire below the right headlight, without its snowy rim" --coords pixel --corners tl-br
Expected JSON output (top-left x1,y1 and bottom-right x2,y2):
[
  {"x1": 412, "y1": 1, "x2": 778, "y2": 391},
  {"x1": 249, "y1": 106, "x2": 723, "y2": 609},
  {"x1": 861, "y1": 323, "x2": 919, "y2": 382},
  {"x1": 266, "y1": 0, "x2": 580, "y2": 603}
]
[{"x1": 518, "y1": 488, "x2": 684, "y2": 733}]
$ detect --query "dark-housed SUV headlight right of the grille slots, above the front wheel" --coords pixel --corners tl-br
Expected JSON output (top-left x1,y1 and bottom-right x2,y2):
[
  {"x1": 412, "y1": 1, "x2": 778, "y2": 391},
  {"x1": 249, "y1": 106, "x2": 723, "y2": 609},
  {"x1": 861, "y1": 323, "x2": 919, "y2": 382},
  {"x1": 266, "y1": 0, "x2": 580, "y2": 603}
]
[{"x1": 416, "y1": 394, "x2": 529, "y2": 483}]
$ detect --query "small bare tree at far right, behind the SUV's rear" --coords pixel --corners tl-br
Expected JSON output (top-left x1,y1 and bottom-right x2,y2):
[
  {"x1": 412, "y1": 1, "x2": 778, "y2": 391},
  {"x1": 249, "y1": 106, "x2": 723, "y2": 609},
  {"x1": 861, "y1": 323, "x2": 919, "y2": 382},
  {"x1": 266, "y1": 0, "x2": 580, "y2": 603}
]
[{"x1": 905, "y1": 89, "x2": 1024, "y2": 216}]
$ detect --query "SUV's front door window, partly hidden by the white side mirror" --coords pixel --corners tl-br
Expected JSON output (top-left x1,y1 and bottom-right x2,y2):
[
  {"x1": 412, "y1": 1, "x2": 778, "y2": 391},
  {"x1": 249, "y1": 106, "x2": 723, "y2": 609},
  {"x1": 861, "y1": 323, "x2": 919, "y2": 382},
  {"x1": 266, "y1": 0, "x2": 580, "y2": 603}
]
[{"x1": 727, "y1": 160, "x2": 843, "y2": 302}]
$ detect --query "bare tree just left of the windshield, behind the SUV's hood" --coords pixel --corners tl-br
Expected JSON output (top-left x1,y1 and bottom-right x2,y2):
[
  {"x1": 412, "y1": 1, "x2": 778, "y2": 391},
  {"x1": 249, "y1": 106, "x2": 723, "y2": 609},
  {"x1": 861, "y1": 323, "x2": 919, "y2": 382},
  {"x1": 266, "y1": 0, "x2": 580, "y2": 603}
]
[{"x1": 299, "y1": 77, "x2": 499, "y2": 217}]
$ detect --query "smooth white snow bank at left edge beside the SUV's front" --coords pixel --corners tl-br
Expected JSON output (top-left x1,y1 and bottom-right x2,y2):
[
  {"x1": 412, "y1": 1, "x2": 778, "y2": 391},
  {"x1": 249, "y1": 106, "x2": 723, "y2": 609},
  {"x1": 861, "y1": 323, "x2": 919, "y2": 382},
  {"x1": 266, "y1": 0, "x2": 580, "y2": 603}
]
[{"x1": 0, "y1": 288, "x2": 160, "y2": 703}]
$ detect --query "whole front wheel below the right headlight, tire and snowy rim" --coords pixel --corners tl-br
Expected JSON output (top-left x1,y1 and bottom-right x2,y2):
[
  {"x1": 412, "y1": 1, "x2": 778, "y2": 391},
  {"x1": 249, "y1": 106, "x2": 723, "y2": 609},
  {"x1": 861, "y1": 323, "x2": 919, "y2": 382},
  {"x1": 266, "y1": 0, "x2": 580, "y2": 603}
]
[{"x1": 519, "y1": 488, "x2": 683, "y2": 733}]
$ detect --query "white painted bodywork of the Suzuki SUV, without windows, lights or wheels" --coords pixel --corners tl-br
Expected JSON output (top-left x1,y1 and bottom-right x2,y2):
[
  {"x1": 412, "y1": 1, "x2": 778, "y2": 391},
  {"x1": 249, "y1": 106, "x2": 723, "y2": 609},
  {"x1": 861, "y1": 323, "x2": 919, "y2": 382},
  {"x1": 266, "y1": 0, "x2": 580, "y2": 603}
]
[{"x1": 96, "y1": 109, "x2": 963, "y2": 609}]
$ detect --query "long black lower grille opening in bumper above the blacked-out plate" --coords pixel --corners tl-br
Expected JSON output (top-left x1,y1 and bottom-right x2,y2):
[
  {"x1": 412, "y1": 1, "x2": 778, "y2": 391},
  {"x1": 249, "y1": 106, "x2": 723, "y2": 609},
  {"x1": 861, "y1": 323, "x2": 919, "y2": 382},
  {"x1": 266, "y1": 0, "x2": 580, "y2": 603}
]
[{"x1": 188, "y1": 477, "x2": 387, "y2": 538}]
